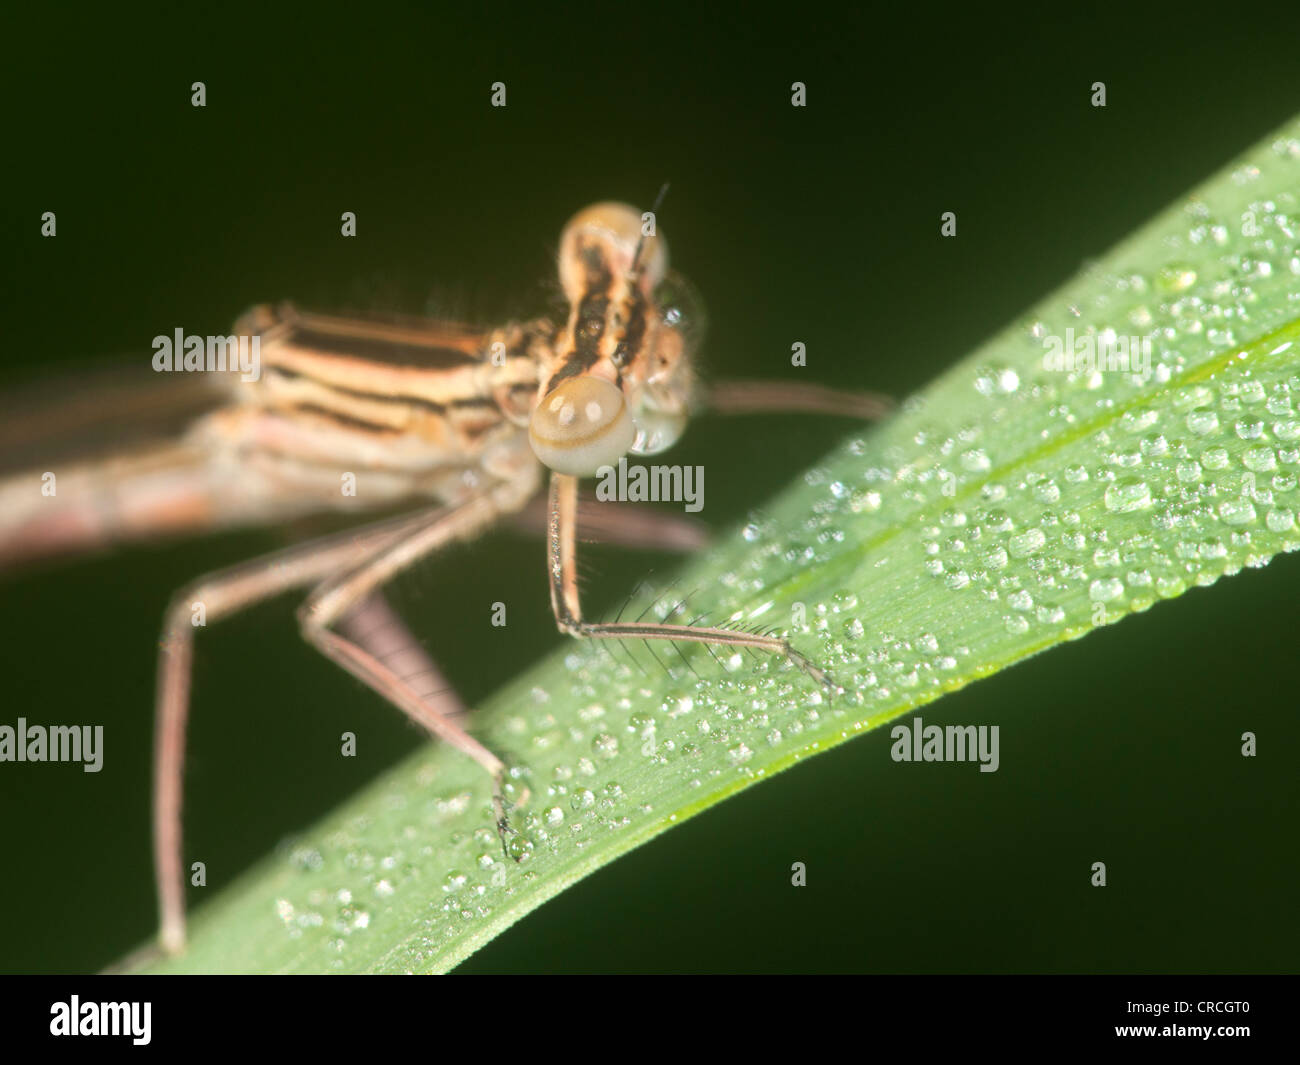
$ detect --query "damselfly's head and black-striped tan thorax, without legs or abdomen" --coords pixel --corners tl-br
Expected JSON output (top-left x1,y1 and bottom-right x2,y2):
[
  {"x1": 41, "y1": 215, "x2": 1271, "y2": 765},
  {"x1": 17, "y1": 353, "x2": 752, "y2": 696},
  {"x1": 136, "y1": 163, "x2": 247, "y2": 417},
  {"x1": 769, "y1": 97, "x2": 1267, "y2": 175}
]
[{"x1": 205, "y1": 203, "x2": 701, "y2": 505}]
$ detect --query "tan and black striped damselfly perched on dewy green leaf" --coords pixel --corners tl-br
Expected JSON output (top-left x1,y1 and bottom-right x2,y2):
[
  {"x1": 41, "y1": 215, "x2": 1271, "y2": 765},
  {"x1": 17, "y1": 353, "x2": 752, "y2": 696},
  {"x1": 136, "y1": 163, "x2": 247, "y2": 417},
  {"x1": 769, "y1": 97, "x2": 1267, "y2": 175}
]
[{"x1": 0, "y1": 203, "x2": 889, "y2": 952}]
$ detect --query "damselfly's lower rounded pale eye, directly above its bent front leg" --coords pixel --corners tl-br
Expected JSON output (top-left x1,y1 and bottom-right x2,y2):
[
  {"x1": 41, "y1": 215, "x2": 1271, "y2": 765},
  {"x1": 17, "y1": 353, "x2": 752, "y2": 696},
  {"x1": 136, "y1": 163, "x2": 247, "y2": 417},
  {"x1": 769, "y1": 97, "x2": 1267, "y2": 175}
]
[{"x1": 528, "y1": 376, "x2": 637, "y2": 477}]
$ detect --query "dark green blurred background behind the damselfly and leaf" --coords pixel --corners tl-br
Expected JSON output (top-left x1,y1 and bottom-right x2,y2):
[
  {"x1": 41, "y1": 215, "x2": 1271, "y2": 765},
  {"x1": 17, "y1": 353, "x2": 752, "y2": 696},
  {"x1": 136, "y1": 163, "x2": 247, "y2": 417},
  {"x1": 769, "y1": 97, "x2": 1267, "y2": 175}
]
[{"x1": 0, "y1": 4, "x2": 1300, "y2": 971}]
